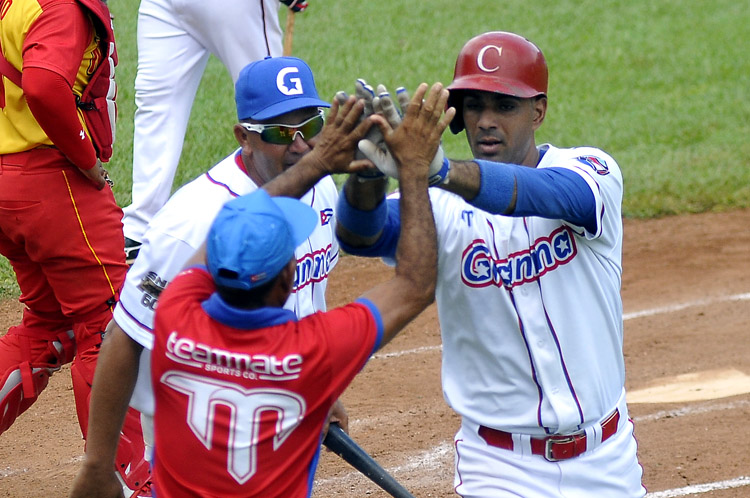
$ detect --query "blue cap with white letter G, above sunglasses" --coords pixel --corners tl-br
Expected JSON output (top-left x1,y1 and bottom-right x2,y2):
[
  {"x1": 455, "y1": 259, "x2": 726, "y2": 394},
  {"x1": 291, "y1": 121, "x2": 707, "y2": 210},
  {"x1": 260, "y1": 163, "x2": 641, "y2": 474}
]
[{"x1": 234, "y1": 57, "x2": 331, "y2": 121}]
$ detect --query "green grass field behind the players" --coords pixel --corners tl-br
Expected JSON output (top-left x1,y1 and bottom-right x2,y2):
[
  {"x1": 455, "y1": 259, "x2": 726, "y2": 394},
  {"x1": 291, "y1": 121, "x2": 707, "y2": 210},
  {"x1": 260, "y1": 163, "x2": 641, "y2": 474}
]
[{"x1": 0, "y1": 0, "x2": 750, "y2": 295}]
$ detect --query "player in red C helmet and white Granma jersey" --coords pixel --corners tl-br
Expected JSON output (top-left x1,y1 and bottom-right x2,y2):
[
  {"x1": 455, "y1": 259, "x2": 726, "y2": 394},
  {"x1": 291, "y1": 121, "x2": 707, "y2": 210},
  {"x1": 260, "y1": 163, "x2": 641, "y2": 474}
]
[{"x1": 337, "y1": 32, "x2": 645, "y2": 498}]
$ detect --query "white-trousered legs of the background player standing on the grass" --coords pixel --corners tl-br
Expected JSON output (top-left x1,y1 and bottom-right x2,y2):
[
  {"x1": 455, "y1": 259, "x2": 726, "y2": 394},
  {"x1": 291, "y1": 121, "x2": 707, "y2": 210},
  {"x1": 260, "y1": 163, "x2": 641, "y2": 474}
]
[{"x1": 123, "y1": 0, "x2": 307, "y2": 263}]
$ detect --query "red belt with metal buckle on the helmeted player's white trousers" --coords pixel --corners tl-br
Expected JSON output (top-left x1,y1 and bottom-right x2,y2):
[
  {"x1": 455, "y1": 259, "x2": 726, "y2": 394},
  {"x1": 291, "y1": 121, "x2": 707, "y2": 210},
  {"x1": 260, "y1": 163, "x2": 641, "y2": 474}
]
[{"x1": 479, "y1": 409, "x2": 620, "y2": 462}]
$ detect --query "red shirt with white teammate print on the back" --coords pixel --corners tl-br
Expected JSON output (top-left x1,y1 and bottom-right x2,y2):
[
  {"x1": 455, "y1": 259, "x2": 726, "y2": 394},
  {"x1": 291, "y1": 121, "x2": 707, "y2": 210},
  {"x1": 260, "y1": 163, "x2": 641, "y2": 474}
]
[{"x1": 151, "y1": 267, "x2": 383, "y2": 498}]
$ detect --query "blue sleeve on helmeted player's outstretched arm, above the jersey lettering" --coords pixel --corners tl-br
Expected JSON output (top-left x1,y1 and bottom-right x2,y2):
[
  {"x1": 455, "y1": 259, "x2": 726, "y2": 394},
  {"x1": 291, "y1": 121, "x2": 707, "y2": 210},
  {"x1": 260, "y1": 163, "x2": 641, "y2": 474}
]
[{"x1": 470, "y1": 160, "x2": 596, "y2": 232}]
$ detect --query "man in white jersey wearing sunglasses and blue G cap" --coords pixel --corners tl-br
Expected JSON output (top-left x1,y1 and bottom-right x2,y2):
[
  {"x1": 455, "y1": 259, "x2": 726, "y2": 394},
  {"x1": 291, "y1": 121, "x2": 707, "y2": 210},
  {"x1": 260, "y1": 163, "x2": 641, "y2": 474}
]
[{"x1": 72, "y1": 57, "x2": 365, "y2": 497}]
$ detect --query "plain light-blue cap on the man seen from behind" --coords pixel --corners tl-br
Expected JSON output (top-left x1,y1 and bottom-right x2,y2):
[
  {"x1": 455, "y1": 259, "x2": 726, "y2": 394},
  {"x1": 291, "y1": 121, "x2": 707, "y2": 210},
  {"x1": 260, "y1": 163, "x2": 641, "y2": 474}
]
[{"x1": 206, "y1": 189, "x2": 318, "y2": 290}]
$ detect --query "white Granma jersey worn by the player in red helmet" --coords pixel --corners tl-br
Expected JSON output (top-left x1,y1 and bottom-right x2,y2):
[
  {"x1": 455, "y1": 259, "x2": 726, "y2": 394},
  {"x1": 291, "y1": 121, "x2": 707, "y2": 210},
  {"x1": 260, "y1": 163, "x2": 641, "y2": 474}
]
[{"x1": 431, "y1": 145, "x2": 626, "y2": 435}]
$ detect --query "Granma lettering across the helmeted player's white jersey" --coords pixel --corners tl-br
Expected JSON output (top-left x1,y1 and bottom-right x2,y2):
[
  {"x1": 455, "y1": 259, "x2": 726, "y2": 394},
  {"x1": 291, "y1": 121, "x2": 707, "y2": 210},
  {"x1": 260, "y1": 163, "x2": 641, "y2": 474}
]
[{"x1": 461, "y1": 226, "x2": 578, "y2": 289}]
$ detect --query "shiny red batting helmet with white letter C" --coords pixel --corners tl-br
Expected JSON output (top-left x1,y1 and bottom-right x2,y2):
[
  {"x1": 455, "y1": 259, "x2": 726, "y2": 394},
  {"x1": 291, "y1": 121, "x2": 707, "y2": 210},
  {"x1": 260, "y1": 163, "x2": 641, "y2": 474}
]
[{"x1": 448, "y1": 31, "x2": 547, "y2": 133}]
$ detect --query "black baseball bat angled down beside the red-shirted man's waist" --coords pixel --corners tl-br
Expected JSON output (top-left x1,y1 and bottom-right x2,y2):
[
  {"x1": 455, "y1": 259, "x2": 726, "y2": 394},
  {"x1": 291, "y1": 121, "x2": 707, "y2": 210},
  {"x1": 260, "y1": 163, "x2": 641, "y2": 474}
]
[{"x1": 323, "y1": 423, "x2": 414, "y2": 498}]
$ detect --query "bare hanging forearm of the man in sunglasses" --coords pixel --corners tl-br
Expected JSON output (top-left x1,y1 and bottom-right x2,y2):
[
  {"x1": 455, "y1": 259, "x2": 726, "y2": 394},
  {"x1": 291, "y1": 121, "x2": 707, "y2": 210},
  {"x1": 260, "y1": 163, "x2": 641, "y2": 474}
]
[{"x1": 85, "y1": 320, "x2": 143, "y2": 470}]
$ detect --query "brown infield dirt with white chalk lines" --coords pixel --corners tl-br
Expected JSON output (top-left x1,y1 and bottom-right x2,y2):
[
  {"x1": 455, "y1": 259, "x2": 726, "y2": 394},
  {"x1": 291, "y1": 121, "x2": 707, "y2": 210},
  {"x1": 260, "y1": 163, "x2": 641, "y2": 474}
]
[{"x1": 0, "y1": 210, "x2": 750, "y2": 498}]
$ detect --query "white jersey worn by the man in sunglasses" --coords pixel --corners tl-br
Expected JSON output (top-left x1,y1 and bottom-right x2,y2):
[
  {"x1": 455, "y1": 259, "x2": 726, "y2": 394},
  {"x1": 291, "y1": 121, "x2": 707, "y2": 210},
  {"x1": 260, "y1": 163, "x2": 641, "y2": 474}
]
[{"x1": 114, "y1": 149, "x2": 339, "y2": 414}]
